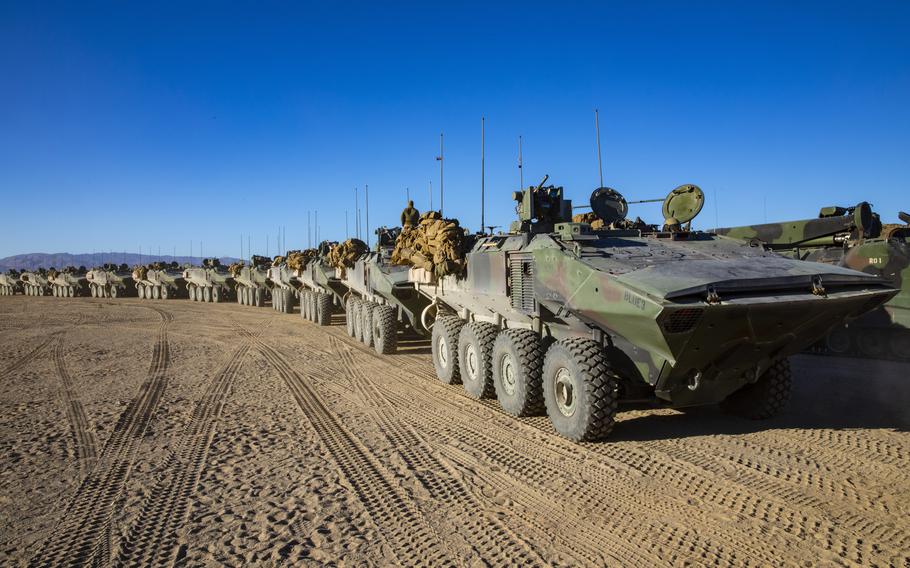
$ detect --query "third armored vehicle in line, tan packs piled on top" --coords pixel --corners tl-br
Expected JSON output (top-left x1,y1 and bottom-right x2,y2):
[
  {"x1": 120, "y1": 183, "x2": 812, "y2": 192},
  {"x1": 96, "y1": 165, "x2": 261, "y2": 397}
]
[{"x1": 297, "y1": 241, "x2": 349, "y2": 325}]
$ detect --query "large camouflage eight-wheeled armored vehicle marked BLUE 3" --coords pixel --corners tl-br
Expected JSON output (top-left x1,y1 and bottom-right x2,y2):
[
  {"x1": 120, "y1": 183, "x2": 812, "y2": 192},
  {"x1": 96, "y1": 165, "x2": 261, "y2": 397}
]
[{"x1": 411, "y1": 178, "x2": 896, "y2": 440}]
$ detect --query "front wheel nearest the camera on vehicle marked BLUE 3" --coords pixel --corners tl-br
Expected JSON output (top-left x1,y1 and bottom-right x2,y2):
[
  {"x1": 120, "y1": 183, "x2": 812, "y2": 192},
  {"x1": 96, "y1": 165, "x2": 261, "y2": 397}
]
[{"x1": 543, "y1": 337, "x2": 619, "y2": 442}]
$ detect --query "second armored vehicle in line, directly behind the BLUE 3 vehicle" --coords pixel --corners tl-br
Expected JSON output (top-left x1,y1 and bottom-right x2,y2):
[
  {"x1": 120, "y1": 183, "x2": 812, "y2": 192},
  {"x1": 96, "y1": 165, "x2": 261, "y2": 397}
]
[{"x1": 342, "y1": 227, "x2": 430, "y2": 354}]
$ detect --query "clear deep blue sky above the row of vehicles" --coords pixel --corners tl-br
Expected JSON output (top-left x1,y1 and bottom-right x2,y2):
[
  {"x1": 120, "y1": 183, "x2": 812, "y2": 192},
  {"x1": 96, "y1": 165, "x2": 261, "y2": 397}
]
[{"x1": 0, "y1": 0, "x2": 910, "y2": 256}]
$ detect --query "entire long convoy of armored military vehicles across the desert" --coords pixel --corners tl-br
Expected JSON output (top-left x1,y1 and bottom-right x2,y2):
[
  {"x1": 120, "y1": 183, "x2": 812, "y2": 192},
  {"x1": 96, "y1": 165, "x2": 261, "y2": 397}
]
[{"x1": 0, "y1": 184, "x2": 910, "y2": 441}]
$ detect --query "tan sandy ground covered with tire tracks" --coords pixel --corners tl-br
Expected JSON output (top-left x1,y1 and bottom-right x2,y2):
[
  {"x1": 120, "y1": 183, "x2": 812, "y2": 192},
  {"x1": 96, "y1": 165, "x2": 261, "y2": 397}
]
[{"x1": 0, "y1": 296, "x2": 910, "y2": 567}]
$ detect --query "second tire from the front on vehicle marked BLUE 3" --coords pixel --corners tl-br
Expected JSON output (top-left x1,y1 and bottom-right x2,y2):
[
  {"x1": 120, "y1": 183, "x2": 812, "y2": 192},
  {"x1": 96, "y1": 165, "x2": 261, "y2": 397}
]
[{"x1": 492, "y1": 329, "x2": 544, "y2": 416}]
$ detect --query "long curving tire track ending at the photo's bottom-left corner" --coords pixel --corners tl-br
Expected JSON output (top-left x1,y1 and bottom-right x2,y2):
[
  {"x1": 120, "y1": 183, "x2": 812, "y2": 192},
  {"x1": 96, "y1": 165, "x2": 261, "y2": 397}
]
[{"x1": 29, "y1": 306, "x2": 173, "y2": 566}]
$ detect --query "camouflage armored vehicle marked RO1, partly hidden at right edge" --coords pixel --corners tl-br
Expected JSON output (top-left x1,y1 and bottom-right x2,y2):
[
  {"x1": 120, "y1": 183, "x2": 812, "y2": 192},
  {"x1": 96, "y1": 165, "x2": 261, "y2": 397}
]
[{"x1": 715, "y1": 207, "x2": 910, "y2": 360}]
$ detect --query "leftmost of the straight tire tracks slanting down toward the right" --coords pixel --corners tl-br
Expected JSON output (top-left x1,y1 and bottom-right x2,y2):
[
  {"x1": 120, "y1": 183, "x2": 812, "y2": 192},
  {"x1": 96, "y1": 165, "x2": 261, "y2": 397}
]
[{"x1": 246, "y1": 330, "x2": 453, "y2": 566}]
